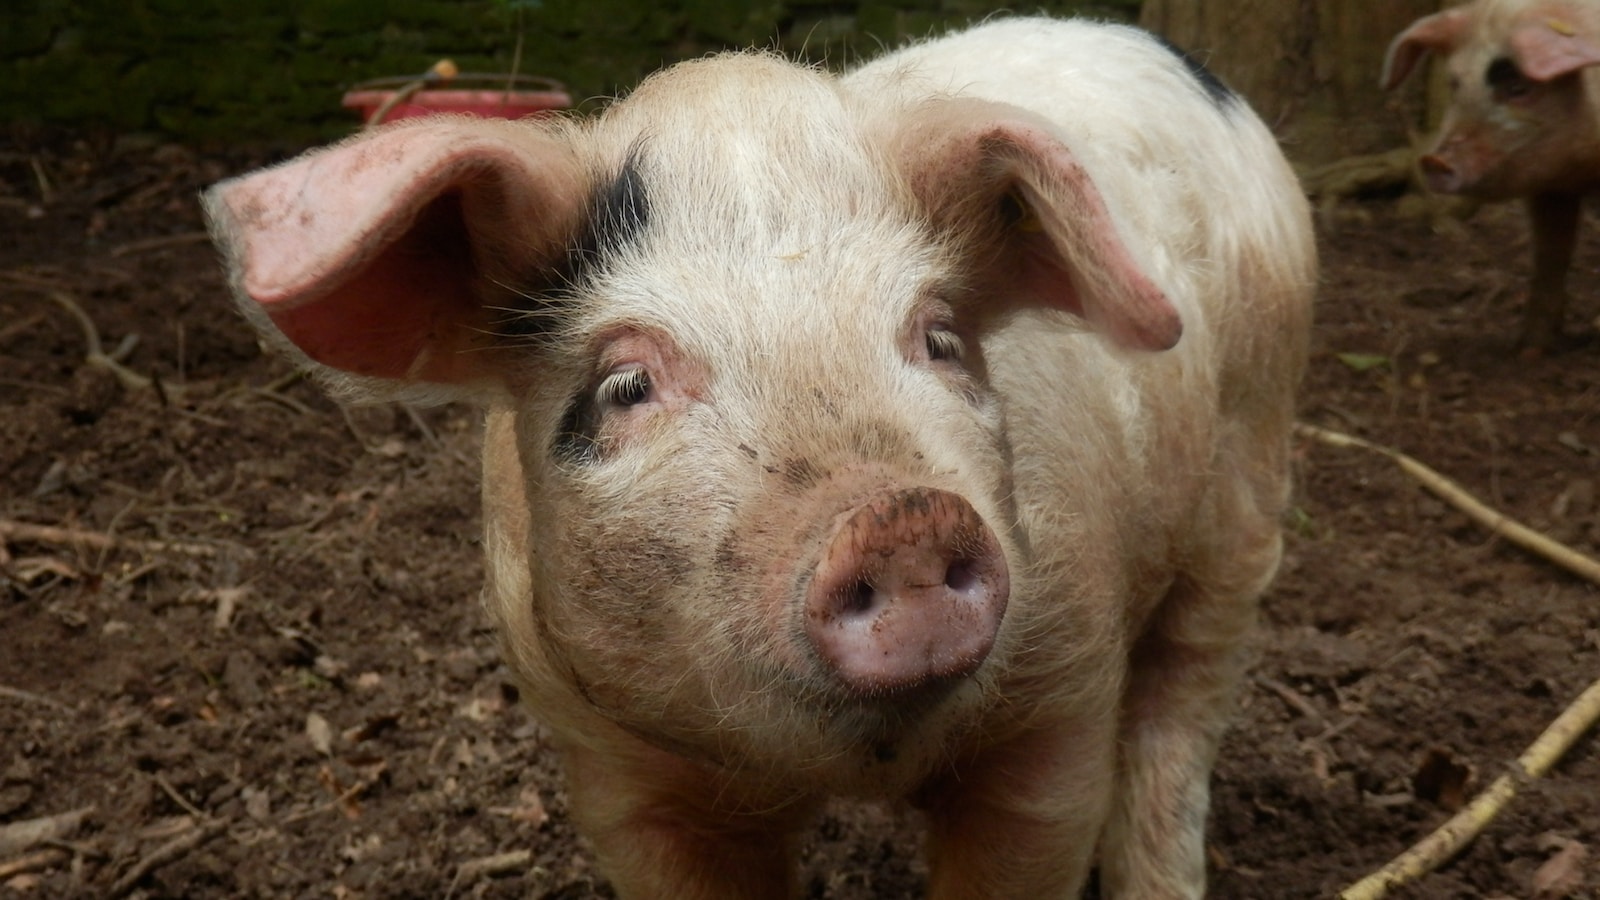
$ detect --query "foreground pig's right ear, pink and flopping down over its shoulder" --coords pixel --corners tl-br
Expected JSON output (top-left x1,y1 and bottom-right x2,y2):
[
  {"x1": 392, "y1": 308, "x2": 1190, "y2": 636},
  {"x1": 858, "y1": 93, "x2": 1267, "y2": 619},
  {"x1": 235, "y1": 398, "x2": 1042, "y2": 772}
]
[{"x1": 896, "y1": 99, "x2": 1184, "y2": 351}]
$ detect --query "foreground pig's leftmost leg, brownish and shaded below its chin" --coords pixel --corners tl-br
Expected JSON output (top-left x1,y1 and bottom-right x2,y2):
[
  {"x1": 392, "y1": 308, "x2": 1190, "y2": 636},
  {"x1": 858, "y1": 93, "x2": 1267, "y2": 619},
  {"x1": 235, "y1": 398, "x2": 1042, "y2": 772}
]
[{"x1": 562, "y1": 736, "x2": 813, "y2": 900}]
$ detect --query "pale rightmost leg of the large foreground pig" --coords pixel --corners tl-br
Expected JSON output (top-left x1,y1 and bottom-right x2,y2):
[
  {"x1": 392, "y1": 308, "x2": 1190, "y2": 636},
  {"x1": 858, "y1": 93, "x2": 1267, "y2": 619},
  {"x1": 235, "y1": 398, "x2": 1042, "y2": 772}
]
[{"x1": 1101, "y1": 569, "x2": 1270, "y2": 900}]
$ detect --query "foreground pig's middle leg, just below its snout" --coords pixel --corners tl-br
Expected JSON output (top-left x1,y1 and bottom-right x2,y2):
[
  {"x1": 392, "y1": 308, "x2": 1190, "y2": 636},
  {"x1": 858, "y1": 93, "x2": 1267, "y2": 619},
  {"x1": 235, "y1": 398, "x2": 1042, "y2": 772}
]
[{"x1": 923, "y1": 707, "x2": 1117, "y2": 900}]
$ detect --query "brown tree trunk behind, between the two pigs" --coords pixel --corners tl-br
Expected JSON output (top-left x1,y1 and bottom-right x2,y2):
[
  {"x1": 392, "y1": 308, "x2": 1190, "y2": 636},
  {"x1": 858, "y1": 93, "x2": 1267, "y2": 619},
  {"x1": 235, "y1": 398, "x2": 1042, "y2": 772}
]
[{"x1": 1139, "y1": 0, "x2": 1443, "y2": 163}]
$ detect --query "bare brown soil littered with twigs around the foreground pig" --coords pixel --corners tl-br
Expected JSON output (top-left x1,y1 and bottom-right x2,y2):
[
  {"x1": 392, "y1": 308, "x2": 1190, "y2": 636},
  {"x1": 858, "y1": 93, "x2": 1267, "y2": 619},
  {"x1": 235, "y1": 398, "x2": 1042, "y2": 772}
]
[{"x1": 0, "y1": 135, "x2": 1600, "y2": 900}]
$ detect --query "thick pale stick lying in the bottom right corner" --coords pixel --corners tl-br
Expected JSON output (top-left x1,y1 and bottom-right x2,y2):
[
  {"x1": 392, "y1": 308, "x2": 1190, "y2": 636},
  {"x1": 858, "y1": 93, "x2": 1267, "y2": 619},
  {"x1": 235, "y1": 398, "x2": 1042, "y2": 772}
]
[{"x1": 1339, "y1": 681, "x2": 1600, "y2": 900}]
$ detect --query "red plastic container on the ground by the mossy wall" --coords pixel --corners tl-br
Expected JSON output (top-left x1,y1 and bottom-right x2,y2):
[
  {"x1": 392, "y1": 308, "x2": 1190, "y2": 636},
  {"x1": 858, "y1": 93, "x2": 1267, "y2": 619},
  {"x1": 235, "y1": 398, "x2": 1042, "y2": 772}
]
[{"x1": 342, "y1": 74, "x2": 573, "y2": 122}]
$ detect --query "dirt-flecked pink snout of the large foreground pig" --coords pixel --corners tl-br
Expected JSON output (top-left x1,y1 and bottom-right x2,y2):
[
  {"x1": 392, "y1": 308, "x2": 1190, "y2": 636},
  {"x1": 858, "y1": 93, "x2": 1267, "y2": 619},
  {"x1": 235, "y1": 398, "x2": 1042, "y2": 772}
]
[{"x1": 805, "y1": 488, "x2": 1011, "y2": 697}]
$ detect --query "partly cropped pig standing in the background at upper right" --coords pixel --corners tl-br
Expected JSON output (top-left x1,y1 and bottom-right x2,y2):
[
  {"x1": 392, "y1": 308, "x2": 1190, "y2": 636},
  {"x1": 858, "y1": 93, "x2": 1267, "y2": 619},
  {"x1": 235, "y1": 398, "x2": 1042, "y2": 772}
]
[{"x1": 1382, "y1": 0, "x2": 1600, "y2": 356}]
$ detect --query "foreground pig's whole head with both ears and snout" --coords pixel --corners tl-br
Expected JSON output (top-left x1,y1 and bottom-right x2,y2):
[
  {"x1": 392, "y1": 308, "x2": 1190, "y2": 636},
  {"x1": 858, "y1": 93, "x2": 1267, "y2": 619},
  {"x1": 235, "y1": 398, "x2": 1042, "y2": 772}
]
[{"x1": 206, "y1": 54, "x2": 1181, "y2": 786}]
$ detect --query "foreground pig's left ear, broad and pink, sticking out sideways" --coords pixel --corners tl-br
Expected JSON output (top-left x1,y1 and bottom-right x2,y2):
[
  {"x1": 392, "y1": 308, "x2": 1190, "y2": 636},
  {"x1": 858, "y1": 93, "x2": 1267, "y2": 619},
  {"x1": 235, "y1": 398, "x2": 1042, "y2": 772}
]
[{"x1": 205, "y1": 119, "x2": 584, "y2": 396}]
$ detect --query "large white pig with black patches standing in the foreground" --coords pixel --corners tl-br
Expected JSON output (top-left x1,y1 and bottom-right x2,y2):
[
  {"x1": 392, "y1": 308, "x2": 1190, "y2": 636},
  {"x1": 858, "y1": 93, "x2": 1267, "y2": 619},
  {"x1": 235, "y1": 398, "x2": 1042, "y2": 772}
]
[{"x1": 205, "y1": 18, "x2": 1315, "y2": 900}]
